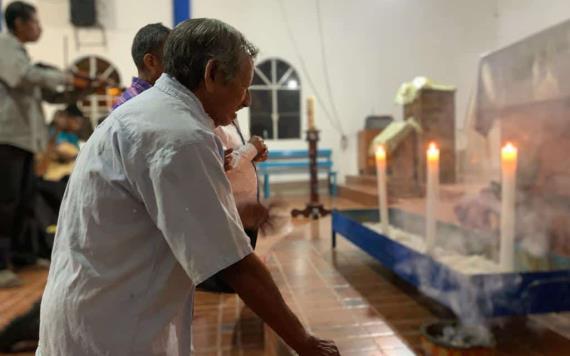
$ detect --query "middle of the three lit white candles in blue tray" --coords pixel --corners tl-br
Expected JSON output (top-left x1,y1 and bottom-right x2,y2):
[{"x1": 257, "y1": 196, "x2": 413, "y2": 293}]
[{"x1": 426, "y1": 142, "x2": 439, "y2": 253}]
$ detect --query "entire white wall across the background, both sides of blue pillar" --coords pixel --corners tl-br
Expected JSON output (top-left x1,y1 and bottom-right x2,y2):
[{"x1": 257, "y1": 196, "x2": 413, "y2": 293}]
[{"x1": 3, "y1": 0, "x2": 570, "y2": 180}]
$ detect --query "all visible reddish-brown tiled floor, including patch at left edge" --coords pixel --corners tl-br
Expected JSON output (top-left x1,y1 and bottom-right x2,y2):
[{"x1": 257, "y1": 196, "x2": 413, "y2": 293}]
[{"x1": 0, "y1": 199, "x2": 570, "y2": 356}]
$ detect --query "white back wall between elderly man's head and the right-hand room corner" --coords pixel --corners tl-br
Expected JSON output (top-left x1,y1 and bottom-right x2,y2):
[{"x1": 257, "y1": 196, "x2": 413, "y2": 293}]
[{"x1": 192, "y1": 0, "x2": 497, "y2": 180}]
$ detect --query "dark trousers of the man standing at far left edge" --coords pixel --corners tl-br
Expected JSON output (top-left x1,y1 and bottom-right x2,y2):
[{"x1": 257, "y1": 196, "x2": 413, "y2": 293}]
[{"x1": 0, "y1": 144, "x2": 35, "y2": 269}]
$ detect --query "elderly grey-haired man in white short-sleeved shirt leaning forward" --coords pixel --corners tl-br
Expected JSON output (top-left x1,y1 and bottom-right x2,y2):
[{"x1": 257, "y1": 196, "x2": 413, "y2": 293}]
[{"x1": 37, "y1": 19, "x2": 338, "y2": 356}]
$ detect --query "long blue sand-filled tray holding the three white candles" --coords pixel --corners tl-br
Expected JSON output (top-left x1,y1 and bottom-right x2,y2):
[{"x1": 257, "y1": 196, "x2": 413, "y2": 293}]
[{"x1": 332, "y1": 209, "x2": 570, "y2": 317}]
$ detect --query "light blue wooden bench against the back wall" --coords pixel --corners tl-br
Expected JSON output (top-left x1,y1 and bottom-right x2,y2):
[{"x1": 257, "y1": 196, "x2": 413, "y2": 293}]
[{"x1": 257, "y1": 149, "x2": 336, "y2": 199}]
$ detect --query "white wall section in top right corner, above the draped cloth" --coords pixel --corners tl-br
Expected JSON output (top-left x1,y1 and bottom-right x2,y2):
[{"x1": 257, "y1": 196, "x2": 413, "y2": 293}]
[{"x1": 497, "y1": 0, "x2": 570, "y2": 47}]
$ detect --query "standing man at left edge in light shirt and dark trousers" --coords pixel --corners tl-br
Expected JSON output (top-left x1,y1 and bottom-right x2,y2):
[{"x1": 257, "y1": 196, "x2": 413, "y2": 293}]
[{"x1": 0, "y1": 1, "x2": 87, "y2": 287}]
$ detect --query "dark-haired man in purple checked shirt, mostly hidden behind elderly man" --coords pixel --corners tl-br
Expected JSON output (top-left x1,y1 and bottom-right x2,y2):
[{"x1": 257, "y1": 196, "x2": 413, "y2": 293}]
[{"x1": 113, "y1": 23, "x2": 170, "y2": 109}]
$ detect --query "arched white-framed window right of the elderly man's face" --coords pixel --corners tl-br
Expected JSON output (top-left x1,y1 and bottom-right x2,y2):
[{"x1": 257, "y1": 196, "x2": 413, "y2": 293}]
[{"x1": 249, "y1": 58, "x2": 301, "y2": 140}]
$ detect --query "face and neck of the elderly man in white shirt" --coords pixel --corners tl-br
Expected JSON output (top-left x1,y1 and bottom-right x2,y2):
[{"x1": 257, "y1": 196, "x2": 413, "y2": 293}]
[{"x1": 202, "y1": 55, "x2": 253, "y2": 126}]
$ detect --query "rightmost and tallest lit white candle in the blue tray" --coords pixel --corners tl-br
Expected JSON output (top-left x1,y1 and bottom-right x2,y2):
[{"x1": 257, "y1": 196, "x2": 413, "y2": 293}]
[{"x1": 499, "y1": 142, "x2": 517, "y2": 271}]
